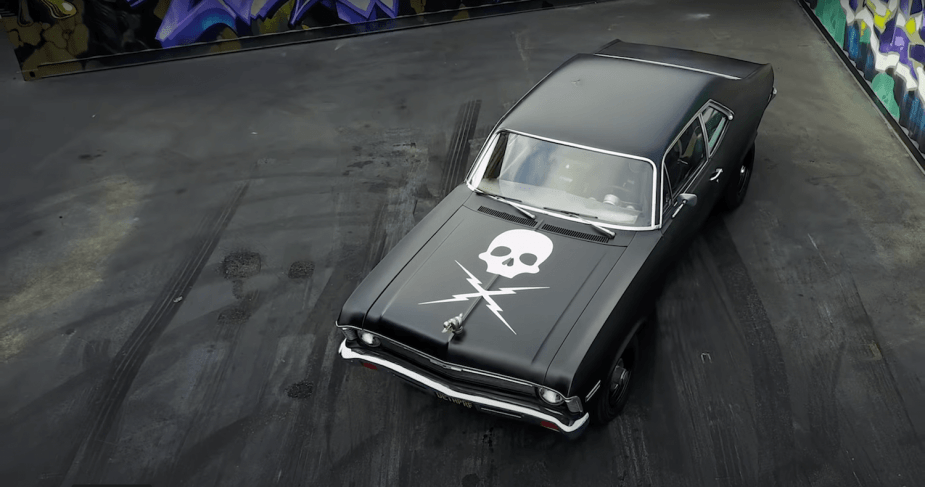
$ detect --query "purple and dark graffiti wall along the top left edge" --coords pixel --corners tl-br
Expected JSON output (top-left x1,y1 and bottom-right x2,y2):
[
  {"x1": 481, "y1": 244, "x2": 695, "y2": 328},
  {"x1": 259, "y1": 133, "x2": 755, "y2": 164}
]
[{"x1": 0, "y1": 0, "x2": 564, "y2": 80}]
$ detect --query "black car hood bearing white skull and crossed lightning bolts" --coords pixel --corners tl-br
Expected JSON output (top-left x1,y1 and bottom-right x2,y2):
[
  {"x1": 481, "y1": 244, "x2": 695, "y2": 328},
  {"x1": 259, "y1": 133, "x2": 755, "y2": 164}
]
[{"x1": 363, "y1": 206, "x2": 624, "y2": 382}]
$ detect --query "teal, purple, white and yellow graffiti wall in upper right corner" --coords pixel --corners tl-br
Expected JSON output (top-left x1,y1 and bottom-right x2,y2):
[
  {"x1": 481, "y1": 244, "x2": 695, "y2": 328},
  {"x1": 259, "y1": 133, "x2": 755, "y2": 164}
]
[{"x1": 804, "y1": 0, "x2": 925, "y2": 151}]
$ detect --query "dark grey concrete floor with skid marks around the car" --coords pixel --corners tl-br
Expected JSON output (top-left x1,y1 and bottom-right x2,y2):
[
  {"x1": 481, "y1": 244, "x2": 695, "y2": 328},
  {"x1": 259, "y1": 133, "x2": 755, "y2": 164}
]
[{"x1": 0, "y1": 0, "x2": 925, "y2": 487}]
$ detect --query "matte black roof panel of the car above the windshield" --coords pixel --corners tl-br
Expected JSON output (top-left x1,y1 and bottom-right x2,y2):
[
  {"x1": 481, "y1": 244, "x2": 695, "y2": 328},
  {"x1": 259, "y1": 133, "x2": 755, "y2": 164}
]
[{"x1": 499, "y1": 54, "x2": 723, "y2": 166}]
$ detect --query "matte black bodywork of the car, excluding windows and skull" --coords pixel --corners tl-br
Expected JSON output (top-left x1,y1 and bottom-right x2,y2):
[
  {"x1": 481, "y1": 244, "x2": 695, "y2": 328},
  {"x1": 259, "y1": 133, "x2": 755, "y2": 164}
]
[{"x1": 337, "y1": 41, "x2": 776, "y2": 435}]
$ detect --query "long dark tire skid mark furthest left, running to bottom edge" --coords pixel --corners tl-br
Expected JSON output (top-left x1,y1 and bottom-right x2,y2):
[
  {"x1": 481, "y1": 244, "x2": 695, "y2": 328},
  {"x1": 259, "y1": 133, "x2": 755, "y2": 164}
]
[{"x1": 61, "y1": 183, "x2": 250, "y2": 486}]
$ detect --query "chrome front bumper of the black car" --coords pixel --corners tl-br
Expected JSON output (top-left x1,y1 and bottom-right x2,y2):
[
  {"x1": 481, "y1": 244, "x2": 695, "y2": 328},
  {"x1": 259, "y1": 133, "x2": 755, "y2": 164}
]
[{"x1": 338, "y1": 340, "x2": 589, "y2": 438}]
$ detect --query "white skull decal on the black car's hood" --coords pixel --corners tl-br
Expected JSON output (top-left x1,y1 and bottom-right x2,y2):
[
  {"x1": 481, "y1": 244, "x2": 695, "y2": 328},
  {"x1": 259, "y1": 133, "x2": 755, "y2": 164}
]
[{"x1": 479, "y1": 230, "x2": 552, "y2": 279}]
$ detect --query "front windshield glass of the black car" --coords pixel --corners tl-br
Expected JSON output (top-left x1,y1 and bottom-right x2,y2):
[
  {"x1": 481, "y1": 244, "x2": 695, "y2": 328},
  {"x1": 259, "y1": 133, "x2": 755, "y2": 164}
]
[{"x1": 475, "y1": 132, "x2": 654, "y2": 228}]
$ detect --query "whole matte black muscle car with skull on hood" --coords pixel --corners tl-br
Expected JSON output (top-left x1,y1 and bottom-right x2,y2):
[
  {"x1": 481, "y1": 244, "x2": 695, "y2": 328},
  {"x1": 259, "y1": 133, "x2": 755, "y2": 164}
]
[{"x1": 336, "y1": 40, "x2": 776, "y2": 437}]
